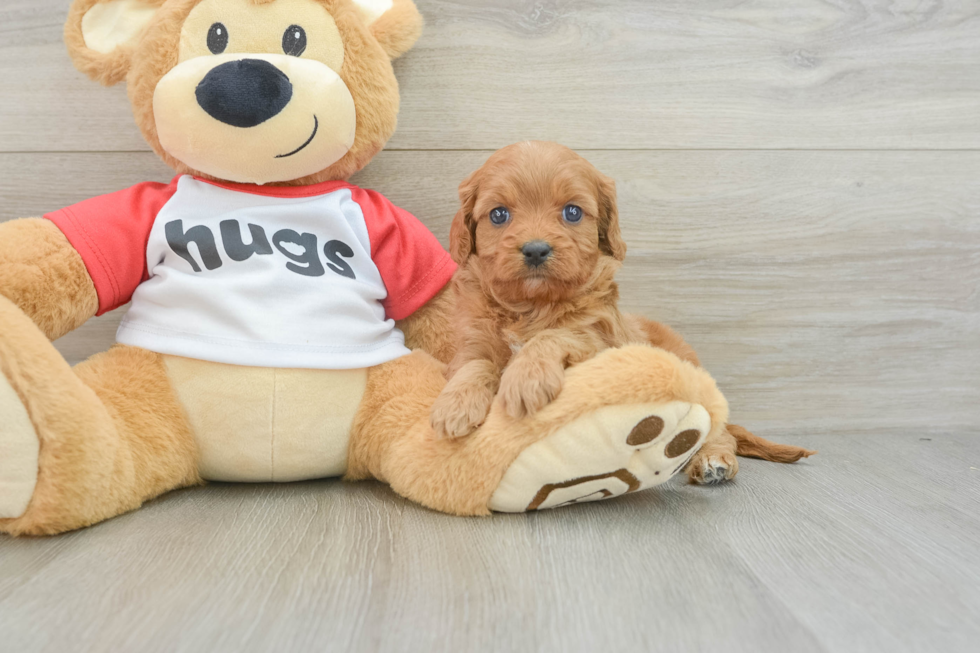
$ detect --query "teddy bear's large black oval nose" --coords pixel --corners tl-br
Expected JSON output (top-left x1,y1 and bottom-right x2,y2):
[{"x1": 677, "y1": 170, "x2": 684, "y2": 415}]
[{"x1": 196, "y1": 59, "x2": 293, "y2": 127}]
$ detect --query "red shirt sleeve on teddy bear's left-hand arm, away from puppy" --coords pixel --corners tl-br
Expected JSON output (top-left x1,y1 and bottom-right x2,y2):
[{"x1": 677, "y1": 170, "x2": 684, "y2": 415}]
[{"x1": 44, "y1": 179, "x2": 177, "y2": 315}]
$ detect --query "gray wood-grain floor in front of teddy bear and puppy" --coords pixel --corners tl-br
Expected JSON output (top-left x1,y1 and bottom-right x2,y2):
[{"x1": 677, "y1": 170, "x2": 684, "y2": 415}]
[{"x1": 0, "y1": 433, "x2": 980, "y2": 653}]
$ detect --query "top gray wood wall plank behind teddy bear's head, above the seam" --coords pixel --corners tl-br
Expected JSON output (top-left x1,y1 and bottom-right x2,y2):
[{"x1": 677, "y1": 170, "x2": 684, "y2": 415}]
[{"x1": 0, "y1": 0, "x2": 980, "y2": 152}]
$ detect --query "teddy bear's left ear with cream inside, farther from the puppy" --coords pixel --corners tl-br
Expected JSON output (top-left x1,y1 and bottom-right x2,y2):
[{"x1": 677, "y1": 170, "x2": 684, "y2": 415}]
[{"x1": 65, "y1": 0, "x2": 164, "y2": 86}]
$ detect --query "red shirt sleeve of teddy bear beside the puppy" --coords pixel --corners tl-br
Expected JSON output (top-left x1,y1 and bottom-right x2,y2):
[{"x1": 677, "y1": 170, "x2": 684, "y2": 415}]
[{"x1": 351, "y1": 188, "x2": 456, "y2": 320}]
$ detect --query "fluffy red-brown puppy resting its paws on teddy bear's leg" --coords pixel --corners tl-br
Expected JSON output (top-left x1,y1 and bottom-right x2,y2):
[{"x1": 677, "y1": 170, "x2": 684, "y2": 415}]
[{"x1": 431, "y1": 142, "x2": 803, "y2": 482}]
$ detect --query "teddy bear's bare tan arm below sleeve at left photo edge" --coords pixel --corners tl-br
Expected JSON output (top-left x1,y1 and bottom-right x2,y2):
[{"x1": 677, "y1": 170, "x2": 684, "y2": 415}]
[{"x1": 0, "y1": 218, "x2": 99, "y2": 340}]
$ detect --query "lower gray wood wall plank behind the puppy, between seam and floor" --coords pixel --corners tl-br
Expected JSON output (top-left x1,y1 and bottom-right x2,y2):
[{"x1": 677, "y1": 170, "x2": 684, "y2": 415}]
[{"x1": 0, "y1": 151, "x2": 980, "y2": 437}]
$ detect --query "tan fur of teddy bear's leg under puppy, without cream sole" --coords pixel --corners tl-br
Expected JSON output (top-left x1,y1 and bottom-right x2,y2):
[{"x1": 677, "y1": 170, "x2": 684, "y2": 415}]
[{"x1": 347, "y1": 345, "x2": 728, "y2": 515}]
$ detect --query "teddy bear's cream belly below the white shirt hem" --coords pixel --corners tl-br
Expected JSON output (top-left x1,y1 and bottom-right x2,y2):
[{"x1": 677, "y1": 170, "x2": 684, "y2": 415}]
[{"x1": 166, "y1": 356, "x2": 367, "y2": 482}]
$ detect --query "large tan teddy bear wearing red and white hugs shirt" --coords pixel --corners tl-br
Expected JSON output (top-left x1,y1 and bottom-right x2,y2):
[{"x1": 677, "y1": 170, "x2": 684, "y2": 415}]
[{"x1": 0, "y1": 0, "x2": 735, "y2": 535}]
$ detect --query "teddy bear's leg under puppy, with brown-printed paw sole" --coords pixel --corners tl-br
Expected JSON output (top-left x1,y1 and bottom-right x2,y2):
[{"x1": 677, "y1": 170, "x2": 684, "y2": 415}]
[{"x1": 348, "y1": 345, "x2": 728, "y2": 515}]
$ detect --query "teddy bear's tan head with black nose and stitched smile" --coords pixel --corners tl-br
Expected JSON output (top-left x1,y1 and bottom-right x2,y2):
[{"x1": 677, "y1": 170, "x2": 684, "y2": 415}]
[{"x1": 65, "y1": 0, "x2": 422, "y2": 184}]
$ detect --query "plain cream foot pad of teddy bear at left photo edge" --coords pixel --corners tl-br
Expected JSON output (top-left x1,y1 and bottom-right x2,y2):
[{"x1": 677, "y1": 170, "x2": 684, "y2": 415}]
[{"x1": 0, "y1": 372, "x2": 40, "y2": 519}]
